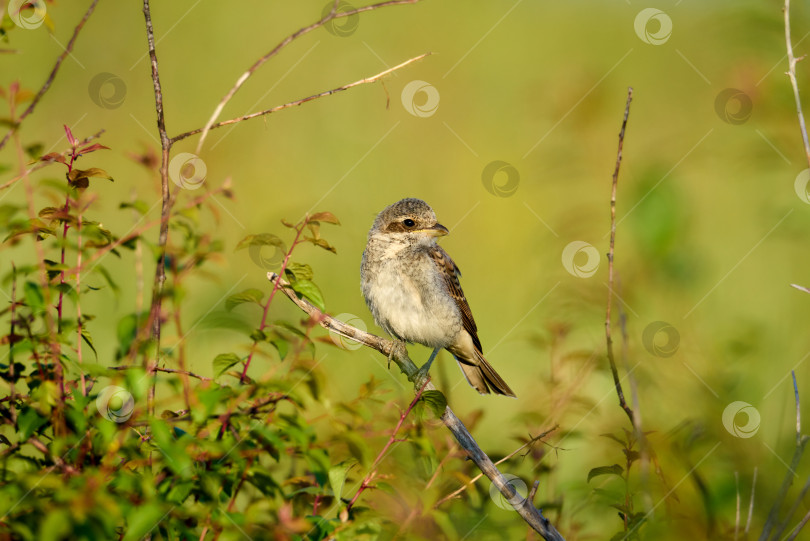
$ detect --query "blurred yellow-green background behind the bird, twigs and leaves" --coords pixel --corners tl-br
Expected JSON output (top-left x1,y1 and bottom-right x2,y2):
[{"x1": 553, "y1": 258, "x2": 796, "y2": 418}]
[{"x1": 0, "y1": 0, "x2": 810, "y2": 539}]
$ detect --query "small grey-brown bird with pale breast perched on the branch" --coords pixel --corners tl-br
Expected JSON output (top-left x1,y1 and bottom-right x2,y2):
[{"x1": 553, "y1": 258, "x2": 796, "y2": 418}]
[{"x1": 360, "y1": 198, "x2": 515, "y2": 397}]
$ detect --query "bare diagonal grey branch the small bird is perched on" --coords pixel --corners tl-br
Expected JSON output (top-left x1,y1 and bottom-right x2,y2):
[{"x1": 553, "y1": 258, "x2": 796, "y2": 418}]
[{"x1": 267, "y1": 272, "x2": 563, "y2": 541}]
